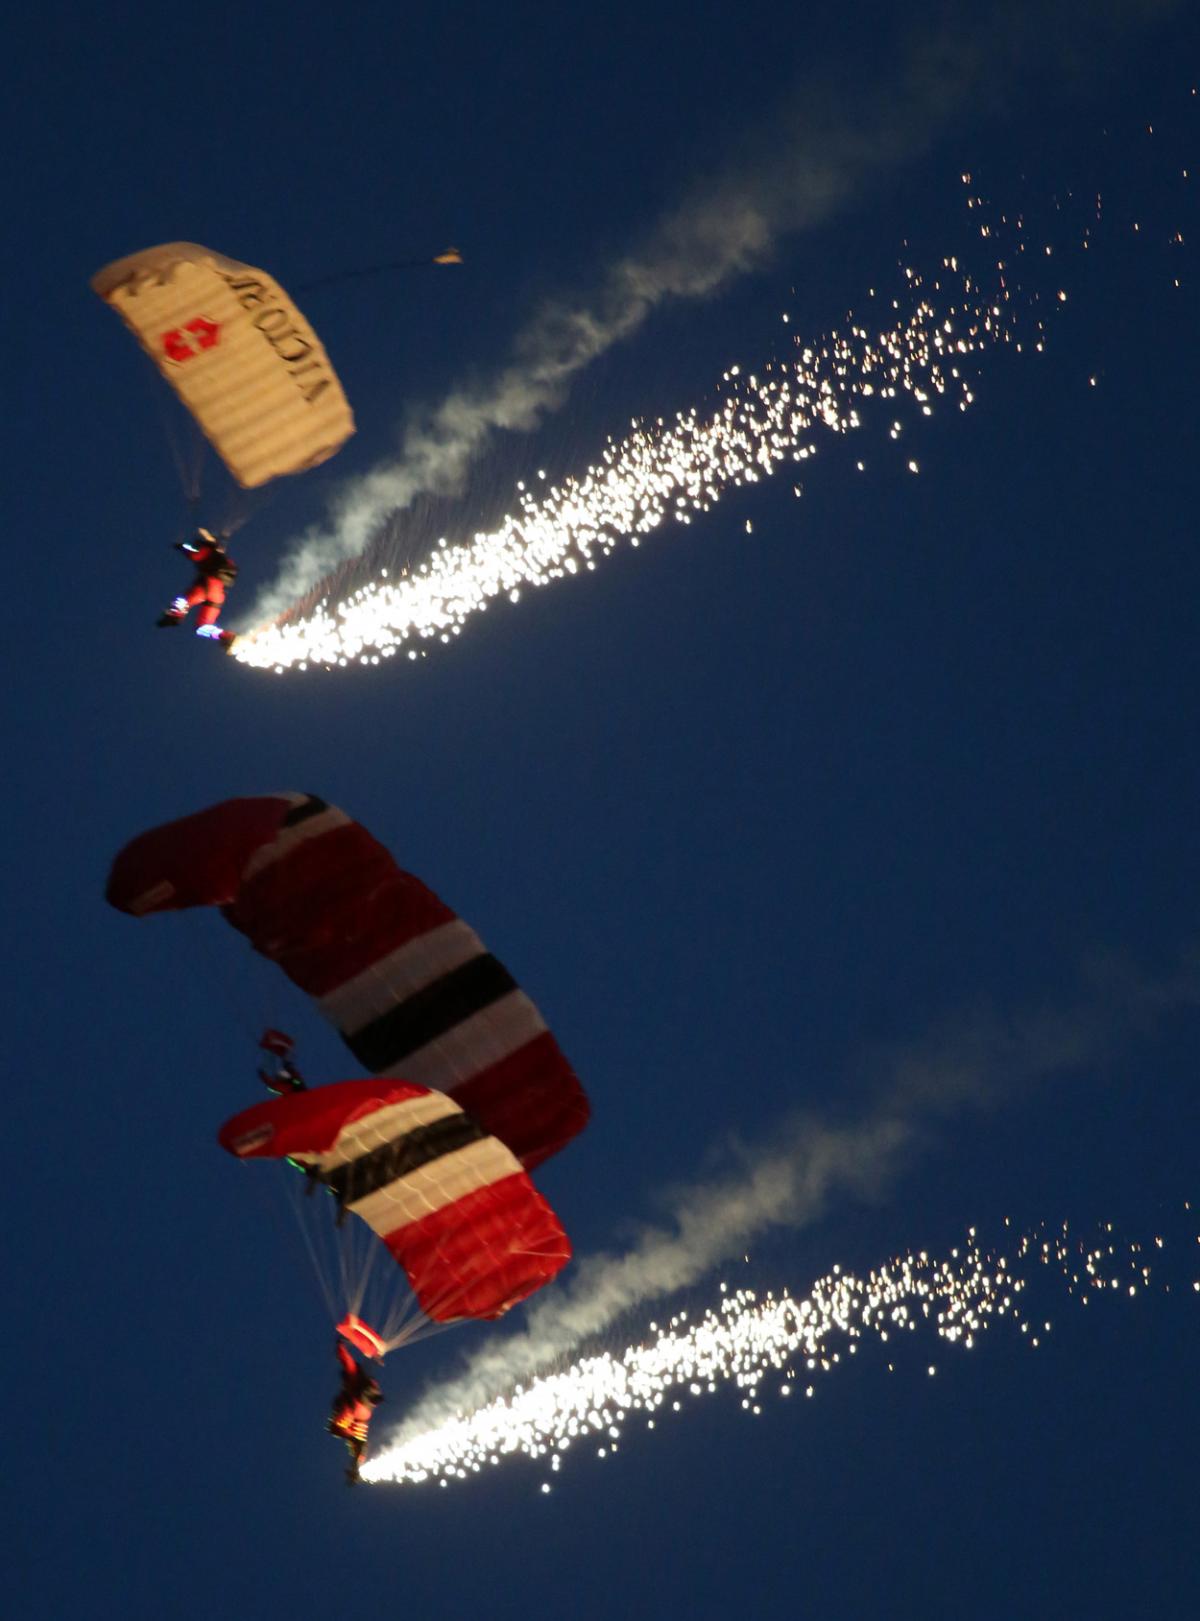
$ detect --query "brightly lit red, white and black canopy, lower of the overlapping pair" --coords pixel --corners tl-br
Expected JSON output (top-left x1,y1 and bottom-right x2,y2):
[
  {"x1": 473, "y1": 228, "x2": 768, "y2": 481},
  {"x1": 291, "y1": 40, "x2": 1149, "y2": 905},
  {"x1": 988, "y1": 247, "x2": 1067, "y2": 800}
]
[{"x1": 219, "y1": 1076, "x2": 571, "y2": 1323}]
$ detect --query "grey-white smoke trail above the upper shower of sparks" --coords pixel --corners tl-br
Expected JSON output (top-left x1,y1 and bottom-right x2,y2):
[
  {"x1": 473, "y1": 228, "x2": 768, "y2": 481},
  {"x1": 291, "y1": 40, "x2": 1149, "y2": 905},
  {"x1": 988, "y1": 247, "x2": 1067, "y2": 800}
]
[{"x1": 242, "y1": 0, "x2": 1176, "y2": 629}]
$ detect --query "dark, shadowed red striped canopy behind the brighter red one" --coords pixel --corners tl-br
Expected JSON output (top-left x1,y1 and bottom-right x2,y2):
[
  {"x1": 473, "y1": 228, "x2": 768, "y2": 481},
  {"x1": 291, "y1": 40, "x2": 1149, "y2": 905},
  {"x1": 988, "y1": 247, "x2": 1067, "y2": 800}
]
[{"x1": 107, "y1": 794, "x2": 589, "y2": 1169}]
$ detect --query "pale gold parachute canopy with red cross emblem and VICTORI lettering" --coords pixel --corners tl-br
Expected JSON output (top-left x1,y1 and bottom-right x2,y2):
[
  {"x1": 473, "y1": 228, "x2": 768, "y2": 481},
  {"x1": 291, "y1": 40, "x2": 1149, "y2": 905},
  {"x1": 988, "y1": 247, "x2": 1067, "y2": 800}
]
[{"x1": 92, "y1": 242, "x2": 354, "y2": 490}]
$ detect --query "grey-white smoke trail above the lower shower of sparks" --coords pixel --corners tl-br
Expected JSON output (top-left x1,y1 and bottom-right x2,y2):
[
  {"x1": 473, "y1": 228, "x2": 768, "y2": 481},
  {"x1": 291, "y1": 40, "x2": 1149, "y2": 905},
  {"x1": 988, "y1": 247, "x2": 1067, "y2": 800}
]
[{"x1": 377, "y1": 960, "x2": 1200, "y2": 1444}]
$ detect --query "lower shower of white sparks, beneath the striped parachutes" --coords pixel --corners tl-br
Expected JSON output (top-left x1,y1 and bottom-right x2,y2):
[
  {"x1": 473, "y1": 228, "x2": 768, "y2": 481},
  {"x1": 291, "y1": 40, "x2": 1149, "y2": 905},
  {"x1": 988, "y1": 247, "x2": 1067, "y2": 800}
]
[{"x1": 363, "y1": 1222, "x2": 1200, "y2": 1491}]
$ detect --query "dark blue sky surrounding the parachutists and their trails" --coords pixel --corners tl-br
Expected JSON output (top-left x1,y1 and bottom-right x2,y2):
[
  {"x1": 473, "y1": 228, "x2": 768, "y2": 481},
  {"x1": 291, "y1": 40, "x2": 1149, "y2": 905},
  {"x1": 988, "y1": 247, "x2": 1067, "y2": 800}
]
[{"x1": 3, "y1": 0, "x2": 1200, "y2": 1621}]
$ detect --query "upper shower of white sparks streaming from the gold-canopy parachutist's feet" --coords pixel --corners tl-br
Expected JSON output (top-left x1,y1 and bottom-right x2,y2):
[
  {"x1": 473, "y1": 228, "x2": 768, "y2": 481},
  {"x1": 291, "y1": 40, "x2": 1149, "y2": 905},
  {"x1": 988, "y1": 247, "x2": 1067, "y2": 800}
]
[{"x1": 234, "y1": 186, "x2": 1065, "y2": 673}]
